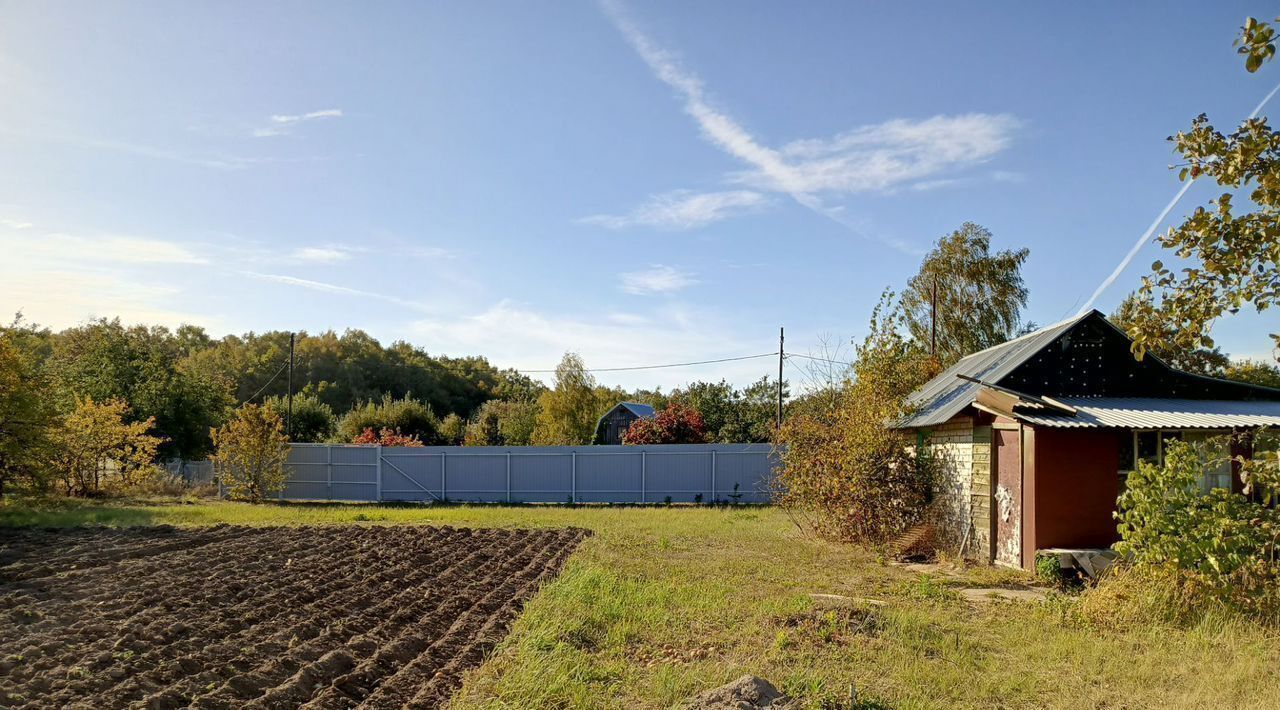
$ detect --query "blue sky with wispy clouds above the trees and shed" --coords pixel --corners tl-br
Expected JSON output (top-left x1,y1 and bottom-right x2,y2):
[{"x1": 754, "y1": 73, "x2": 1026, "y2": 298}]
[{"x1": 0, "y1": 0, "x2": 1276, "y2": 386}]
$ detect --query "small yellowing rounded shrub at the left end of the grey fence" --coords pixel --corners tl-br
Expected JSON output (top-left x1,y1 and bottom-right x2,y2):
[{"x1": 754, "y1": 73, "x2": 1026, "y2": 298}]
[{"x1": 211, "y1": 404, "x2": 289, "y2": 503}]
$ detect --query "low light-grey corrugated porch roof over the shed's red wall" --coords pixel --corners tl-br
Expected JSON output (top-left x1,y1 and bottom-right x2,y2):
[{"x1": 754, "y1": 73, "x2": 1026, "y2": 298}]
[{"x1": 1014, "y1": 397, "x2": 1280, "y2": 429}]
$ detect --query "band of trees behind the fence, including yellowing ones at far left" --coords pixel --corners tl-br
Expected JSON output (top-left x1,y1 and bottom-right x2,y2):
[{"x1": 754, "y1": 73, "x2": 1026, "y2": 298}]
[{"x1": 0, "y1": 315, "x2": 777, "y2": 494}]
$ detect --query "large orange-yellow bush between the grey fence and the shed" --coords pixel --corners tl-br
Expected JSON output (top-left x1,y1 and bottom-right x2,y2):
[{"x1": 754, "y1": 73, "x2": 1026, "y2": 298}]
[{"x1": 777, "y1": 293, "x2": 936, "y2": 542}]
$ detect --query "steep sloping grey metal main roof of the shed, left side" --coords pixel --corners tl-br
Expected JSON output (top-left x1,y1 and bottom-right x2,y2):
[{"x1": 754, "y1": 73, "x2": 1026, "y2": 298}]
[{"x1": 897, "y1": 311, "x2": 1102, "y2": 429}]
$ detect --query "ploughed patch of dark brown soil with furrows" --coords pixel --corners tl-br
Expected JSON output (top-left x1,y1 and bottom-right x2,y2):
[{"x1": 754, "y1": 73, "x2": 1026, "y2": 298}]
[{"x1": 0, "y1": 526, "x2": 586, "y2": 707}]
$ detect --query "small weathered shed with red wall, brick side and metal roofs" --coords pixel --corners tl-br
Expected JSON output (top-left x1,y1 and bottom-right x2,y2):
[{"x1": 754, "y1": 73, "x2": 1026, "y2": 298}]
[{"x1": 900, "y1": 311, "x2": 1280, "y2": 568}]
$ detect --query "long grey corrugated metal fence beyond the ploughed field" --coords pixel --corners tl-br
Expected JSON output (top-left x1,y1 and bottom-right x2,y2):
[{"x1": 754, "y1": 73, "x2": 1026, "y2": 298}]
[{"x1": 282, "y1": 444, "x2": 777, "y2": 503}]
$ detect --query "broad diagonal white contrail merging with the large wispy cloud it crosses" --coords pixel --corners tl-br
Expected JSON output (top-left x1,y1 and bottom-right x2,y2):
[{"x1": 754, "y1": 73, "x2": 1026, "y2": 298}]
[{"x1": 600, "y1": 0, "x2": 1018, "y2": 252}]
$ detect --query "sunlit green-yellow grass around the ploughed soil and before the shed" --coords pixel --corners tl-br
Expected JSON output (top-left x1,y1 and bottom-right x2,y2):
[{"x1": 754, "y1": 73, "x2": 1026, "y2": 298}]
[{"x1": 0, "y1": 501, "x2": 1280, "y2": 707}]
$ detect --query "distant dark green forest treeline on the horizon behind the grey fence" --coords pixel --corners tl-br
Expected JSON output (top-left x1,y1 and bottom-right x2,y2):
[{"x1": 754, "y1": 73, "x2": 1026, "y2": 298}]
[{"x1": 0, "y1": 315, "x2": 777, "y2": 459}]
